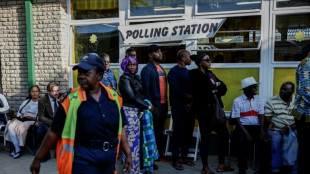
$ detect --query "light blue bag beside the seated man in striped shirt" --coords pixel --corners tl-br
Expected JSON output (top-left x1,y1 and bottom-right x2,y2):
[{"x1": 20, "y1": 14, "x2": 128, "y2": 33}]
[{"x1": 282, "y1": 127, "x2": 298, "y2": 166}]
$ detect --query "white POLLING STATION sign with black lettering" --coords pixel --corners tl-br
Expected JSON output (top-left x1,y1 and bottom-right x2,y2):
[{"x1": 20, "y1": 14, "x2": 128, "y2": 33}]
[{"x1": 118, "y1": 18, "x2": 225, "y2": 44}]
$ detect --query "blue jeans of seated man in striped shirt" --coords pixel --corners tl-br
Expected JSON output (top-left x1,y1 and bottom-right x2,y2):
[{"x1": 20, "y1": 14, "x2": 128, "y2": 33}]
[{"x1": 267, "y1": 129, "x2": 298, "y2": 173}]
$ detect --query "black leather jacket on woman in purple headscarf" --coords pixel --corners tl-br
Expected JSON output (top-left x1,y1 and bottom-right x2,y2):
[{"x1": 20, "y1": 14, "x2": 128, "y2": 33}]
[{"x1": 118, "y1": 74, "x2": 149, "y2": 111}]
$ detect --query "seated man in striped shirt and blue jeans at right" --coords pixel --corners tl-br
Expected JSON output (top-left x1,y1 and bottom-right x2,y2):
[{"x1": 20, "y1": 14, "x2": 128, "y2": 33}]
[{"x1": 265, "y1": 82, "x2": 297, "y2": 173}]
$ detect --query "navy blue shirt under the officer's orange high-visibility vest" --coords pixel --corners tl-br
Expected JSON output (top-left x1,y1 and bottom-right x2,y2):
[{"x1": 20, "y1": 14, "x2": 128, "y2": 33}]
[{"x1": 51, "y1": 87, "x2": 127, "y2": 142}]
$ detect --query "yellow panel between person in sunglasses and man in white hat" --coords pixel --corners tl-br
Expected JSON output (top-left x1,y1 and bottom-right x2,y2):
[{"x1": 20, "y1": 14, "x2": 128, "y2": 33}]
[{"x1": 212, "y1": 68, "x2": 259, "y2": 111}]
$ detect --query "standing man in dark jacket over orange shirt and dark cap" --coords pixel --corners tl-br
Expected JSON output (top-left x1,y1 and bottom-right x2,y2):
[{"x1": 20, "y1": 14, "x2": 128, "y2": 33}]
[{"x1": 141, "y1": 45, "x2": 168, "y2": 159}]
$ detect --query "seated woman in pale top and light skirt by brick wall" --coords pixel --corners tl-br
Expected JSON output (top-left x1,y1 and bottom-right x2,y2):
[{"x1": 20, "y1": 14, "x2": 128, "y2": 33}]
[{"x1": 5, "y1": 85, "x2": 40, "y2": 159}]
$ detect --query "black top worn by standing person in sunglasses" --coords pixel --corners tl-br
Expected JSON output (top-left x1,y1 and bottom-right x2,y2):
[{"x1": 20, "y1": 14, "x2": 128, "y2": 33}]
[{"x1": 189, "y1": 69, "x2": 227, "y2": 109}]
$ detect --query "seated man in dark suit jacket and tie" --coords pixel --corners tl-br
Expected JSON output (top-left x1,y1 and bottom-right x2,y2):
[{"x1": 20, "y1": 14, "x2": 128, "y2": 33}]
[{"x1": 37, "y1": 82, "x2": 59, "y2": 162}]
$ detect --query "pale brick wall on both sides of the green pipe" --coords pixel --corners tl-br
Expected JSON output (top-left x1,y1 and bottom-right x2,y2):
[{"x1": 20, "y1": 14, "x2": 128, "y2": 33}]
[{"x1": 0, "y1": 0, "x2": 69, "y2": 111}]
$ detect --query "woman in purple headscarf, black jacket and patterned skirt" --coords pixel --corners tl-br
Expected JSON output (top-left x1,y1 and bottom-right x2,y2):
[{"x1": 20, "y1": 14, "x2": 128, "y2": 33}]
[{"x1": 119, "y1": 56, "x2": 157, "y2": 174}]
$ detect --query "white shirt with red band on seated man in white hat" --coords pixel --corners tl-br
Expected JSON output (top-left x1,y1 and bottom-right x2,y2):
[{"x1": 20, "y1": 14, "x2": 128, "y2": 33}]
[{"x1": 231, "y1": 93, "x2": 265, "y2": 125}]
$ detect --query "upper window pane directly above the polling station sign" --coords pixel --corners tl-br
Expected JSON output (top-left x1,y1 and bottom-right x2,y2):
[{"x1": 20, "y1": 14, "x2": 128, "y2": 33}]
[{"x1": 130, "y1": 0, "x2": 184, "y2": 16}]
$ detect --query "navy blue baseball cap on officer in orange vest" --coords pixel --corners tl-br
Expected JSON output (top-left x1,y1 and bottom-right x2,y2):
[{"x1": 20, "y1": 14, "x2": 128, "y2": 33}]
[{"x1": 72, "y1": 53, "x2": 105, "y2": 71}]
